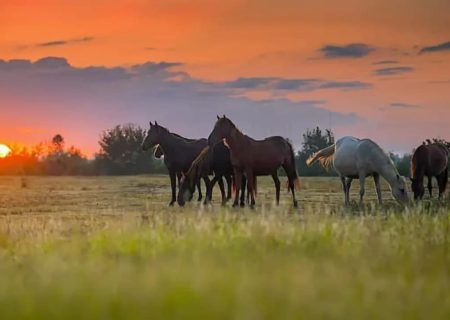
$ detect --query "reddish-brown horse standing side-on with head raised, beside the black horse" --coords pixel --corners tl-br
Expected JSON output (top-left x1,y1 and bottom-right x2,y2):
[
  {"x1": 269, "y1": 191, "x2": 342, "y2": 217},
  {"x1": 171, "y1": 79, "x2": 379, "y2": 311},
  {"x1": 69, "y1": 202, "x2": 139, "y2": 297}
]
[{"x1": 208, "y1": 115, "x2": 300, "y2": 208}]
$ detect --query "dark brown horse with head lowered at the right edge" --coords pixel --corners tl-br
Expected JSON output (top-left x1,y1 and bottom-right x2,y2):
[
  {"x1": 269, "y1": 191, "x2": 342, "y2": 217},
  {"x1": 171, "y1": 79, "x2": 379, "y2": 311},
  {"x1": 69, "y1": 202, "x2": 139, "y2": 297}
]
[{"x1": 411, "y1": 143, "x2": 449, "y2": 200}]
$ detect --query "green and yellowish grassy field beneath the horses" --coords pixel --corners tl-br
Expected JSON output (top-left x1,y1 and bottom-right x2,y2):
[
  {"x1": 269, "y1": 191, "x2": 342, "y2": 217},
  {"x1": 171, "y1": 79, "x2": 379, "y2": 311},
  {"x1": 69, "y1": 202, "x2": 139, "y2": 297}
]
[{"x1": 0, "y1": 176, "x2": 450, "y2": 319}]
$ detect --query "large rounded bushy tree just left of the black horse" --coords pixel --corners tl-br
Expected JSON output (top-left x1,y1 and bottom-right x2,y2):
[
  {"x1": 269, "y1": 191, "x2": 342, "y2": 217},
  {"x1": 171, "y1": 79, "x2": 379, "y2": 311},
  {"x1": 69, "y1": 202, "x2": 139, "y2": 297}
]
[{"x1": 95, "y1": 124, "x2": 155, "y2": 174}]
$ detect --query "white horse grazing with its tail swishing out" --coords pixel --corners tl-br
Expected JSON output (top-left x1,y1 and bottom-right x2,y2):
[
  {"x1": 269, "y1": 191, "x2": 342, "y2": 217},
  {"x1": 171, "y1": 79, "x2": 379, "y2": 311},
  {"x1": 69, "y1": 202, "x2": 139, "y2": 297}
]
[{"x1": 306, "y1": 137, "x2": 408, "y2": 205}]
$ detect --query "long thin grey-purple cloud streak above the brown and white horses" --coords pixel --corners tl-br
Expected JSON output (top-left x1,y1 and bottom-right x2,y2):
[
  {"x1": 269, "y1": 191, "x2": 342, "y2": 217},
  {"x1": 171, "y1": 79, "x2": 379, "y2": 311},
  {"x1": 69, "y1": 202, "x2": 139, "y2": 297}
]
[{"x1": 226, "y1": 77, "x2": 371, "y2": 91}]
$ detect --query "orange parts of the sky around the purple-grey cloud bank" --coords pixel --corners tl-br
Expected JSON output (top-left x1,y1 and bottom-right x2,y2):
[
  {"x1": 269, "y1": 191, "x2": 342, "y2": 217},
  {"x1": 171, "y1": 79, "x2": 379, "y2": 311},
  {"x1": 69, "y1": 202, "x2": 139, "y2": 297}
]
[{"x1": 0, "y1": 0, "x2": 450, "y2": 152}]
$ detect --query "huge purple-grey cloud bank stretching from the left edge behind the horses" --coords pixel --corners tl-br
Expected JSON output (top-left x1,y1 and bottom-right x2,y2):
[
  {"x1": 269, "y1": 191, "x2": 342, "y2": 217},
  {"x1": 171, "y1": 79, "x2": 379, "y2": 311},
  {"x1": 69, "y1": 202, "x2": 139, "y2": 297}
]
[{"x1": 0, "y1": 57, "x2": 364, "y2": 150}]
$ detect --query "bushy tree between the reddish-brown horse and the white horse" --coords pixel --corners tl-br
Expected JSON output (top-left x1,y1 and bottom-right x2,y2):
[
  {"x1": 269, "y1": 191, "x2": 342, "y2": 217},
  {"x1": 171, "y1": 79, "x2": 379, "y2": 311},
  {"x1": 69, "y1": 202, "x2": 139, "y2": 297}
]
[{"x1": 296, "y1": 127, "x2": 335, "y2": 176}]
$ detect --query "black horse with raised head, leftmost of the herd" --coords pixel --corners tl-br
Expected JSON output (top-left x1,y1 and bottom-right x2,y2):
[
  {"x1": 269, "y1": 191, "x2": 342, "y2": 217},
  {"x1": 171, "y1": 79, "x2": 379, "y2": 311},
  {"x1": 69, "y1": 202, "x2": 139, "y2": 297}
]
[{"x1": 142, "y1": 121, "x2": 209, "y2": 206}]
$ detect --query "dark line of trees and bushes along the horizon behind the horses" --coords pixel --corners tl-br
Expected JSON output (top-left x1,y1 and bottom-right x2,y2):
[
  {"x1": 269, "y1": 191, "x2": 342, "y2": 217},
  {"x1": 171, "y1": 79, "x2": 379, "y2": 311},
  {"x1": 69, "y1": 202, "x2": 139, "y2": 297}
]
[{"x1": 0, "y1": 124, "x2": 450, "y2": 176}]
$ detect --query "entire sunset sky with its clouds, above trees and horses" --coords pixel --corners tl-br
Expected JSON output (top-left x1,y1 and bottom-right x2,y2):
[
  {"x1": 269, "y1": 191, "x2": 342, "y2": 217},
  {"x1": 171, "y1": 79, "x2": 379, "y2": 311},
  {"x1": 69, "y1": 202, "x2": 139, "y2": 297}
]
[{"x1": 0, "y1": 0, "x2": 450, "y2": 156}]
